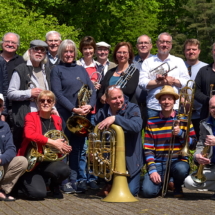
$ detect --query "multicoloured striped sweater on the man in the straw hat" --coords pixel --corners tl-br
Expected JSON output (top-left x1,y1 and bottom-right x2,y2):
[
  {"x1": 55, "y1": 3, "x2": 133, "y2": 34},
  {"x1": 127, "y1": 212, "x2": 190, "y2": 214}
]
[{"x1": 144, "y1": 116, "x2": 196, "y2": 174}]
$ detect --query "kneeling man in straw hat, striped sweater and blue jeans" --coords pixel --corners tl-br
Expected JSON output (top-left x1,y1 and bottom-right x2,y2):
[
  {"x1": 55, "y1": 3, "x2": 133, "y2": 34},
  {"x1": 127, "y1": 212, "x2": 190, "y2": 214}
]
[{"x1": 142, "y1": 85, "x2": 196, "y2": 198}]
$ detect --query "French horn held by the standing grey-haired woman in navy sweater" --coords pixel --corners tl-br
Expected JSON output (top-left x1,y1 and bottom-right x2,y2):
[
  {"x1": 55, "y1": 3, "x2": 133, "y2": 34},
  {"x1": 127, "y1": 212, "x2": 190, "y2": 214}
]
[{"x1": 66, "y1": 77, "x2": 94, "y2": 137}]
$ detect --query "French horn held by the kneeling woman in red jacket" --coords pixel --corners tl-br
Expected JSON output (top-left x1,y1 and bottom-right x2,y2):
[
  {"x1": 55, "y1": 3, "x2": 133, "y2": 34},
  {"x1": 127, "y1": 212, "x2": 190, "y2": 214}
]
[{"x1": 25, "y1": 130, "x2": 69, "y2": 172}]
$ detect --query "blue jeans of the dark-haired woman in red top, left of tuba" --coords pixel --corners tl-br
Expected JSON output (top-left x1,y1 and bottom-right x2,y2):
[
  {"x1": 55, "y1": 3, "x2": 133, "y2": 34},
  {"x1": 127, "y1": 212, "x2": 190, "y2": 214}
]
[{"x1": 78, "y1": 114, "x2": 97, "y2": 182}]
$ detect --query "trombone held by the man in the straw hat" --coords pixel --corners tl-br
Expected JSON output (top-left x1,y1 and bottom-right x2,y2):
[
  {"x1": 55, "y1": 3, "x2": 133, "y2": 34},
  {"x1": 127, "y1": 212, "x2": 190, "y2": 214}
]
[{"x1": 161, "y1": 80, "x2": 196, "y2": 197}]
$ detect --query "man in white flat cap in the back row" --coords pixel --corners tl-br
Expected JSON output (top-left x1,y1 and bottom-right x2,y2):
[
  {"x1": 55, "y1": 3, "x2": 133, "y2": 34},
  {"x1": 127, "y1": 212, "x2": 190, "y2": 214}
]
[{"x1": 95, "y1": 42, "x2": 117, "y2": 77}]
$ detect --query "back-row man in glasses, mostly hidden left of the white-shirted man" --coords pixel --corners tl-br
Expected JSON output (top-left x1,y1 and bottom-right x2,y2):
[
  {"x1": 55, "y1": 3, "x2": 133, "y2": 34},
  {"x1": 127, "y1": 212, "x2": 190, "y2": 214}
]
[{"x1": 133, "y1": 35, "x2": 153, "y2": 128}]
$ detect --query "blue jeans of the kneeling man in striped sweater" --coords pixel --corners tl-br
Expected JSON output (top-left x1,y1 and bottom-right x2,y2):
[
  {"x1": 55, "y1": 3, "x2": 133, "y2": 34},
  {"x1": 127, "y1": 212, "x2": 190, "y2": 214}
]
[{"x1": 141, "y1": 161, "x2": 190, "y2": 198}]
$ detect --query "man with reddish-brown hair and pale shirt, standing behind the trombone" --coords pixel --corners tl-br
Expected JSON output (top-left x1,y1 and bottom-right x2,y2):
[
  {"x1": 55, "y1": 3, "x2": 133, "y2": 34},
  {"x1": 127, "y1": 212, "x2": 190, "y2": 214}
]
[{"x1": 184, "y1": 39, "x2": 207, "y2": 139}]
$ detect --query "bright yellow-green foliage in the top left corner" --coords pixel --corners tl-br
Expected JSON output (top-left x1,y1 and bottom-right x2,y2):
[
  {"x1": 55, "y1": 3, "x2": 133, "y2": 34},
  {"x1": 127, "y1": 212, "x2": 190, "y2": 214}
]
[{"x1": 0, "y1": 0, "x2": 78, "y2": 54}]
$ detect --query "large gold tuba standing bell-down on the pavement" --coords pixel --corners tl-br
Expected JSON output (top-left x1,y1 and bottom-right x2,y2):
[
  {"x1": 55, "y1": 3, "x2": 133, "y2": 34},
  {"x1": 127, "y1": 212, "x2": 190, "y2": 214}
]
[{"x1": 88, "y1": 125, "x2": 138, "y2": 202}]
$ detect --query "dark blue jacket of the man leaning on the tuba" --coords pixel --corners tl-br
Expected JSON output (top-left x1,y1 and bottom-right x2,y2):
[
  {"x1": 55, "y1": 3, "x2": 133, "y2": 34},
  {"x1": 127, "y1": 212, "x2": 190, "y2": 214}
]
[{"x1": 94, "y1": 96, "x2": 143, "y2": 177}]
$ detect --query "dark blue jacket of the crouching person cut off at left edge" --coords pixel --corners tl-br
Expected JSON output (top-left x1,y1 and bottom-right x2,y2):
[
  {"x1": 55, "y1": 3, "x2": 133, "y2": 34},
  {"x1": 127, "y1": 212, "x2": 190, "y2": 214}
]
[{"x1": 0, "y1": 121, "x2": 16, "y2": 166}]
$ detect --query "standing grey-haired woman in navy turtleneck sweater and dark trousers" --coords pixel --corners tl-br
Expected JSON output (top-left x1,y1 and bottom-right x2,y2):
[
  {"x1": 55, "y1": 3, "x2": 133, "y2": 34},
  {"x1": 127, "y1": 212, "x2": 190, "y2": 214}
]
[{"x1": 51, "y1": 40, "x2": 96, "y2": 193}]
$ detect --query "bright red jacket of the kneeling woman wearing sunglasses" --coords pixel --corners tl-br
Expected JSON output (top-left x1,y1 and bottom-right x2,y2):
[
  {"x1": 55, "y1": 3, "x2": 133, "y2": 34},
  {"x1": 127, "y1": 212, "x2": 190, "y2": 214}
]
[{"x1": 17, "y1": 112, "x2": 62, "y2": 156}]
